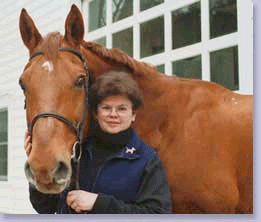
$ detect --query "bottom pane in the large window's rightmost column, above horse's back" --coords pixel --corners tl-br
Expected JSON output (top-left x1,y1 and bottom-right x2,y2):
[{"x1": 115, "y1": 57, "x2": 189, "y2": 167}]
[{"x1": 210, "y1": 46, "x2": 239, "y2": 90}]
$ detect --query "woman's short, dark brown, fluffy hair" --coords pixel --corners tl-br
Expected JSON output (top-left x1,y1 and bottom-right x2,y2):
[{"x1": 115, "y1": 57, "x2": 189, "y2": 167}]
[{"x1": 89, "y1": 71, "x2": 143, "y2": 112}]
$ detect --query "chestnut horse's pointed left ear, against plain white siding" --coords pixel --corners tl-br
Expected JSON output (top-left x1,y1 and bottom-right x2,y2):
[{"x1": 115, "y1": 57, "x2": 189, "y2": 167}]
[{"x1": 19, "y1": 8, "x2": 42, "y2": 52}]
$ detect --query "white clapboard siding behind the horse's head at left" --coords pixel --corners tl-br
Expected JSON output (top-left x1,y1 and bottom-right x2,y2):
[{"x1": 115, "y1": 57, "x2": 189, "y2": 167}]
[{"x1": 0, "y1": 0, "x2": 79, "y2": 214}]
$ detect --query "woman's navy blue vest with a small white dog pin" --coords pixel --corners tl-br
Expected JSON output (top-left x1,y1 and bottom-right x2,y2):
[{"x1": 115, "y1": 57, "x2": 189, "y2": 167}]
[{"x1": 57, "y1": 130, "x2": 156, "y2": 214}]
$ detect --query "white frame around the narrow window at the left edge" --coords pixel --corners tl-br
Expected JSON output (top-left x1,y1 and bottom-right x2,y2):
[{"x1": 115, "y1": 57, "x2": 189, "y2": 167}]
[{"x1": 0, "y1": 94, "x2": 10, "y2": 184}]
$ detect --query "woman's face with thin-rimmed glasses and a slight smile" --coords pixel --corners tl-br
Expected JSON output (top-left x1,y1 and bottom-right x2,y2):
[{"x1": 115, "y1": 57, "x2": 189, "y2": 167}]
[{"x1": 95, "y1": 95, "x2": 136, "y2": 134}]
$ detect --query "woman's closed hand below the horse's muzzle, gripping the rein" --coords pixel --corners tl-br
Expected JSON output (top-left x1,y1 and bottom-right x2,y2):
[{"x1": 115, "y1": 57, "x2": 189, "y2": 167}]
[{"x1": 66, "y1": 190, "x2": 98, "y2": 213}]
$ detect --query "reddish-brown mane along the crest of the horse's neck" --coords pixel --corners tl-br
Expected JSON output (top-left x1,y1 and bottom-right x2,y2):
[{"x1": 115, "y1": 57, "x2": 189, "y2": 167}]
[{"x1": 82, "y1": 41, "x2": 165, "y2": 78}]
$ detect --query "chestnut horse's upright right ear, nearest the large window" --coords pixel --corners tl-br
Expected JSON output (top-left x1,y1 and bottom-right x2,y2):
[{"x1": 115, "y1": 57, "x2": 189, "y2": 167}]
[{"x1": 65, "y1": 4, "x2": 84, "y2": 45}]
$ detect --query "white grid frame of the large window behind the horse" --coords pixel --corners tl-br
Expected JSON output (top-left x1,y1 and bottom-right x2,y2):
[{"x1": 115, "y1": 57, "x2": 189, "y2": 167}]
[{"x1": 82, "y1": 0, "x2": 253, "y2": 94}]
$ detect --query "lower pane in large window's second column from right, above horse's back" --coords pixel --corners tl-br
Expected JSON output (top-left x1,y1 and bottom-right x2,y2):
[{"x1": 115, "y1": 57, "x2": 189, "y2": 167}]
[{"x1": 172, "y1": 55, "x2": 202, "y2": 79}]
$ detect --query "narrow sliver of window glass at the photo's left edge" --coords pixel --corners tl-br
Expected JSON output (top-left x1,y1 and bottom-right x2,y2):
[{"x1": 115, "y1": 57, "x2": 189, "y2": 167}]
[{"x1": 0, "y1": 108, "x2": 8, "y2": 181}]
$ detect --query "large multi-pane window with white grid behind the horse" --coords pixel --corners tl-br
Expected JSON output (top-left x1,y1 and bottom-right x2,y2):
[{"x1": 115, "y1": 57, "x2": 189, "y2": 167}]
[{"x1": 82, "y1": 0, "x2": 253, "y2": 94}]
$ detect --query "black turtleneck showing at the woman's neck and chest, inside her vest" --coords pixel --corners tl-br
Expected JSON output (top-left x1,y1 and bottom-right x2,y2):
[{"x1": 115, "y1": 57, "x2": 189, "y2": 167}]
[{"x1": 93, "y1": 125, "x2": 131, "y2": 170}]
